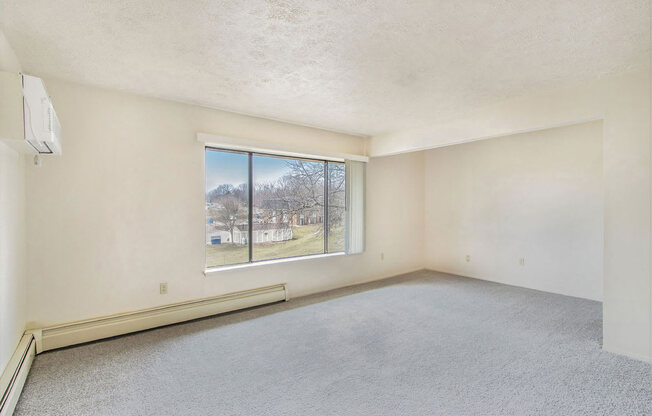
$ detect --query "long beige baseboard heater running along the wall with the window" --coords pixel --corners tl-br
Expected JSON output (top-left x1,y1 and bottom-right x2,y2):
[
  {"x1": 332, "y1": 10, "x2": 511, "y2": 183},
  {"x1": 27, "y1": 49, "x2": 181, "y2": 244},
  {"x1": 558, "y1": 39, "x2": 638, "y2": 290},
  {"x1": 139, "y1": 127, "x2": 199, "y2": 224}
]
[{"x1": 28, "y1": 284, "x2": 289, "y2": 354}]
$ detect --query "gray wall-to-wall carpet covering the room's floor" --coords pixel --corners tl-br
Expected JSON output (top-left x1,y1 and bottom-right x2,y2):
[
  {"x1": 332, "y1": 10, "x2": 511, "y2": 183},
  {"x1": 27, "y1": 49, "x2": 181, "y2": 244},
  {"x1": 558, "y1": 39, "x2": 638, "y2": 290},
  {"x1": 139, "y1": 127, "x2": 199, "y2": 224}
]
[{"x1": 16, "y1": 271, "x2": 652, "y2": 416}]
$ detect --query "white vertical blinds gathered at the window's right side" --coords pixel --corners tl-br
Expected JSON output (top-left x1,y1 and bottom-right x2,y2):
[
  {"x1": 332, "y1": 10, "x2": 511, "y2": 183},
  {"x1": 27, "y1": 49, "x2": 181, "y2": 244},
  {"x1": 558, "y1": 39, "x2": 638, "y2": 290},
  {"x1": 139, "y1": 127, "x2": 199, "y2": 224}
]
[{"x1": 346, "y1": 160, "x2": 366, "y2": 254}]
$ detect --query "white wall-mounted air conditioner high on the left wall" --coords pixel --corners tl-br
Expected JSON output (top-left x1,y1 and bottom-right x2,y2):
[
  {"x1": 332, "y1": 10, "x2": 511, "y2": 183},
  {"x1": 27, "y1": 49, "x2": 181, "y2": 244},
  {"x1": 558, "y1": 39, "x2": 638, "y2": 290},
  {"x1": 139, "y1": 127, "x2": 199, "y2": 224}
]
[{"x1": 0, "y1": 72, "x2": 61, "y2": 155}]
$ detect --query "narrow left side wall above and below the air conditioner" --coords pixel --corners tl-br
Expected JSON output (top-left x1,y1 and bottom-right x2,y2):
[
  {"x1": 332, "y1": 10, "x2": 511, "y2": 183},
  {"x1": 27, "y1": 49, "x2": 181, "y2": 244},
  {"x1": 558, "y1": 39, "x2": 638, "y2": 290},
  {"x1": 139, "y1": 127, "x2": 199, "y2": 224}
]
[{"x1": 0, "y1": 32, "x2": 27, "y2": 373}]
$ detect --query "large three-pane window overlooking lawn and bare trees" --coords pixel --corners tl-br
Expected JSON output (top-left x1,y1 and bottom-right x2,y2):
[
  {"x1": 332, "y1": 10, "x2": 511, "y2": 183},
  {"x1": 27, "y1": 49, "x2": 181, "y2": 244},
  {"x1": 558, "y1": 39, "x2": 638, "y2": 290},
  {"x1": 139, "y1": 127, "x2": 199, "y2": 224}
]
[{"x1": 206, "y1": 148, "x2": 346, "y2": 268}]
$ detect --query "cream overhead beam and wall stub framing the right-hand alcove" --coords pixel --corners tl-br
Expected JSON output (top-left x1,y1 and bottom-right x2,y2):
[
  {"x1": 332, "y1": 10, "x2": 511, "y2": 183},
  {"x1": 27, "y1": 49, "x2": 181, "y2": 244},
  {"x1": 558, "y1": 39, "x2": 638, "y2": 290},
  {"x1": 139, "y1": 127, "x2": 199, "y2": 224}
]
[{"x1": 370, "y1": 70, "x2": 652, "y2": 360}]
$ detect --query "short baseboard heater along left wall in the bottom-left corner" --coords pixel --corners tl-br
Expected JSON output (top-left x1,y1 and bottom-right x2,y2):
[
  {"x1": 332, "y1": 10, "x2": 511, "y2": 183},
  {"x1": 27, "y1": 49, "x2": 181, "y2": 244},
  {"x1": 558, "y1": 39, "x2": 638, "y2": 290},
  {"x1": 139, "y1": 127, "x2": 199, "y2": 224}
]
[{"x1": 0, "y1": 334, "x2": 36, "y2": 416}]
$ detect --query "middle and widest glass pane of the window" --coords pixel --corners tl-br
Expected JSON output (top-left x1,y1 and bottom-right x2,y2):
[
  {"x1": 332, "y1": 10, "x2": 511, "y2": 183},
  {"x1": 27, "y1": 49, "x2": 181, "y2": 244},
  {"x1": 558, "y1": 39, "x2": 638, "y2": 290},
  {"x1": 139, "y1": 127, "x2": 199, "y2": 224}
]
[{"x1": 252, "y1": 155, "x2": 324, "y2": 260}]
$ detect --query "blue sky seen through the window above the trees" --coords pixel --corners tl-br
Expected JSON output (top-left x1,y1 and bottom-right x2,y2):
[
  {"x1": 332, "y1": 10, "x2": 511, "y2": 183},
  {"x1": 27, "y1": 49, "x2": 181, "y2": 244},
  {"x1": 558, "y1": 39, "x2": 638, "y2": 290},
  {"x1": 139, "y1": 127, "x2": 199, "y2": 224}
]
[{"x1": 206, "y1": 150, "x2": 288, "y2": 192}]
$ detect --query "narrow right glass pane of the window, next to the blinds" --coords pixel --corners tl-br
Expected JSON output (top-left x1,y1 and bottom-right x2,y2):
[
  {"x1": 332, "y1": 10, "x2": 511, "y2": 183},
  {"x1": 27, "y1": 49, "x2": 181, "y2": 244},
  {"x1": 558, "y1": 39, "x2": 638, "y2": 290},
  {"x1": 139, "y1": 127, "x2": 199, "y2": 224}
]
[{"x1": 328, "y1": 162, "x2": 346, "y2": 253}]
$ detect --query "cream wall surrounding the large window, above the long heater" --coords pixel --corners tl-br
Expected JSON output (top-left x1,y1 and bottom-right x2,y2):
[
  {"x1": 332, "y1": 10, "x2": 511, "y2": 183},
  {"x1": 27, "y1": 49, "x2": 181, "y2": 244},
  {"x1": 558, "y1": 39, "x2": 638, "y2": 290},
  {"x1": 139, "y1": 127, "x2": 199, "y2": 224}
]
[{"x1": 27, "y1": 80, "x2": 424, "y2": 326}]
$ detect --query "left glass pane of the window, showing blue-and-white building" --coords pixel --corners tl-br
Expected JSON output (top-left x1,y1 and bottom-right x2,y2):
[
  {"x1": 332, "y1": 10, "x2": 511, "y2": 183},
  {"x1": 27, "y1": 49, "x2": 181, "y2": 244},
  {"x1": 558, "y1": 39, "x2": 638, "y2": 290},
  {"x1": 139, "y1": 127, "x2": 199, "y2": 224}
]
[{"x1": 206, "y1": 149, "x2": 249, "y2": 267}]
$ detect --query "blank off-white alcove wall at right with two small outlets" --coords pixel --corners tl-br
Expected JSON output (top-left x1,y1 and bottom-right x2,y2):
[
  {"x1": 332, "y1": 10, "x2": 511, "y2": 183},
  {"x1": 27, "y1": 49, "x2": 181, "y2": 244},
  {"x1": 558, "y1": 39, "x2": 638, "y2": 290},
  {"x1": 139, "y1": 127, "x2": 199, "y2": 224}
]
[{"x1": 425, "y1": 121, "x2": 604, "y2": 300}]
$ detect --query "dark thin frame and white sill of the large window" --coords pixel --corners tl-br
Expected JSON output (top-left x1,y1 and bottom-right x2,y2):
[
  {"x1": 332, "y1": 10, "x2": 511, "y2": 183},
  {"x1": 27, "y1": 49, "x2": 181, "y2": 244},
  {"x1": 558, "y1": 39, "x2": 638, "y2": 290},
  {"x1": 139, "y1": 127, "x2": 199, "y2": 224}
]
[{"x1": 204, "y1": 144, "x2": 348, "y2": 273}]
